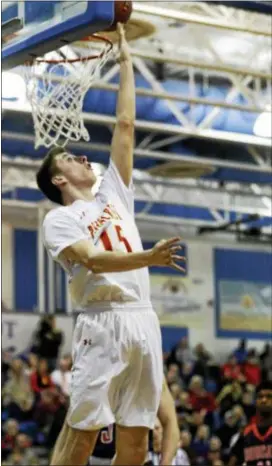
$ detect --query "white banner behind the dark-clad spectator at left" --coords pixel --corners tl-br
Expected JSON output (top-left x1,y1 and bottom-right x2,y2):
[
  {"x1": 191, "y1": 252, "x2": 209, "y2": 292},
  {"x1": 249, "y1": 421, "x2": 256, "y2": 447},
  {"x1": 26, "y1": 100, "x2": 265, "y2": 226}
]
[{"x1": 2, "y1": 312, "x2": 74, "y2": 354}]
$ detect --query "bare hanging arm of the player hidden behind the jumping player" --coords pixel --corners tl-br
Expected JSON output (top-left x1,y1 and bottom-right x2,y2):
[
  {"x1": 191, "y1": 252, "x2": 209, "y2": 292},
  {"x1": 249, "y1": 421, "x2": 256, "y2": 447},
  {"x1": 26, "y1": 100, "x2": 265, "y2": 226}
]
[{"x1": 158, "y1": 379, "x2": 180, "y2": 465}]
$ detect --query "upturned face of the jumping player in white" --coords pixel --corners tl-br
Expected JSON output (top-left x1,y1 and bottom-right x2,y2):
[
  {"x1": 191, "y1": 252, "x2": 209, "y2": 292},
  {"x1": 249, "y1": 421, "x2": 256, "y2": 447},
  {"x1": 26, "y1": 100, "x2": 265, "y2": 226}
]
[{"x1": 56, "y1": 154, "x2": 96, "y2": 188}]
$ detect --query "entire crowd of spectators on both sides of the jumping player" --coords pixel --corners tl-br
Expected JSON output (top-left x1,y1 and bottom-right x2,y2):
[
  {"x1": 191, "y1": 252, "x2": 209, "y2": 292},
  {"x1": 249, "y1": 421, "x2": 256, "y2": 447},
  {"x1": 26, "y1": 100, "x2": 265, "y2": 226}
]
[{"x1": 2, "y1": 317, "x2": 272, "y2": 466}]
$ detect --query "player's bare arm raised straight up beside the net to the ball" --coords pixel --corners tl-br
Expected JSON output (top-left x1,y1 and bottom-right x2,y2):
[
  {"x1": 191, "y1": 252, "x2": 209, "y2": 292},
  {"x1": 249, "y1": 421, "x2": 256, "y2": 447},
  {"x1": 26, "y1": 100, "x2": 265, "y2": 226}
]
[{"x1": 111, "y1": 23, "x2": 135, "y2": 186}]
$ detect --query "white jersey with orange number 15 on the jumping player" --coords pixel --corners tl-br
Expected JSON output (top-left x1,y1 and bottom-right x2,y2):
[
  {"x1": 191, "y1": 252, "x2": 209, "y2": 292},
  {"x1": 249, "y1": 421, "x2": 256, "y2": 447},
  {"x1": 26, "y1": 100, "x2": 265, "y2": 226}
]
[{"x1": 43, "y1": 161, "x2": 150, "y2": 310}]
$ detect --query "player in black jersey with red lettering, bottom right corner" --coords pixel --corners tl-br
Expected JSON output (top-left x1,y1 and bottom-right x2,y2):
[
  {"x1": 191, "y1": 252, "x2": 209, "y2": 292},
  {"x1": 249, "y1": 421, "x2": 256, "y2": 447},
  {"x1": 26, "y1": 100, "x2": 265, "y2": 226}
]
[{"x1": 229, "y1": 382, "x2": 272, "y2": 466}]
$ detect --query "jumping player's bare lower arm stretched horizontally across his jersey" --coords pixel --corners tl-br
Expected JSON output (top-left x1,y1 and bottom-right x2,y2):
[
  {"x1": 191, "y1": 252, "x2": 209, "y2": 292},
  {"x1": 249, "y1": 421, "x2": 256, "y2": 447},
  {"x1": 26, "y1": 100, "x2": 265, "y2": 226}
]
[{"x1": 61, "y1": 237, "x2": 185, "y2": 274}]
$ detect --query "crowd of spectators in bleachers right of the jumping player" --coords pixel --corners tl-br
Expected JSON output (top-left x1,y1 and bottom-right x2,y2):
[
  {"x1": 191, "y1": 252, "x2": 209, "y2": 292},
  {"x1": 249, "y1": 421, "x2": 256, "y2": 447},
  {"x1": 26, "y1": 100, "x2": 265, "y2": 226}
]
[{"x1": 165, "y1": 338, "x2": 272, "y2": 466}]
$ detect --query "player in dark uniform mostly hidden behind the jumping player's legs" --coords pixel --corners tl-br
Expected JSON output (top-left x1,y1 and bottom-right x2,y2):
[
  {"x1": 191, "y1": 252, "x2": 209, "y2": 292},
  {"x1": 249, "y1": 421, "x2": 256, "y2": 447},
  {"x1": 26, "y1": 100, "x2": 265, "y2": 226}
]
[{"x1": 89, "y1": 380, "x2": 182, "y2": 466}]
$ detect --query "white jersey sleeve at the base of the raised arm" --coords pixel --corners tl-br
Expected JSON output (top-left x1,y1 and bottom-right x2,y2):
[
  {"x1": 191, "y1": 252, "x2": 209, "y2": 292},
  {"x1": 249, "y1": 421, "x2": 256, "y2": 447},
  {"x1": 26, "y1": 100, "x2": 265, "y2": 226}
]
[{"x1": 99, "y1": 160, "x2": 134, "y2": 215}]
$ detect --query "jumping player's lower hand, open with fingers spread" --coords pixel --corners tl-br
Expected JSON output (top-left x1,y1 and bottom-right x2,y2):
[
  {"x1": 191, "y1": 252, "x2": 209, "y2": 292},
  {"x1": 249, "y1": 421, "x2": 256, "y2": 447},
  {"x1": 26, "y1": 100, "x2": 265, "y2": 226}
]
[{"x1": 151, "y1": 236, "x2": 186, "y2": 272}]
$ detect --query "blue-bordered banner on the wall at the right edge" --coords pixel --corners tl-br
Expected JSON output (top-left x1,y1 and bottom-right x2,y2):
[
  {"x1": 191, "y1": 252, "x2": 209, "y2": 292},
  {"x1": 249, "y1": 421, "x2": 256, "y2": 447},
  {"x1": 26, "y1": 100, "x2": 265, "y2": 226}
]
[{"x1": 215, "y1": 249, "x2": 272, "y2": 339}]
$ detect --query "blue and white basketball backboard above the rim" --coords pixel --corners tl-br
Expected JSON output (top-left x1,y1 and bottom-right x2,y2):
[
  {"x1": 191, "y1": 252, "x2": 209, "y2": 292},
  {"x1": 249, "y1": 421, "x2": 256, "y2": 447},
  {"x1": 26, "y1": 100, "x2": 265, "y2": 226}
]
[{"x1": 1, "y1": 0, "x2": 114, "y2": 70}]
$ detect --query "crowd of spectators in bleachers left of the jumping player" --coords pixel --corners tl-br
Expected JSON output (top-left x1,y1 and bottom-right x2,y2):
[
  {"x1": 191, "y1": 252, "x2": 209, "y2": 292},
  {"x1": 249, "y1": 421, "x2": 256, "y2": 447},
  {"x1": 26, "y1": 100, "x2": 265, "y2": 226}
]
[{"x1": 2, "y1": 316, "x2": 67, "y2": 465}]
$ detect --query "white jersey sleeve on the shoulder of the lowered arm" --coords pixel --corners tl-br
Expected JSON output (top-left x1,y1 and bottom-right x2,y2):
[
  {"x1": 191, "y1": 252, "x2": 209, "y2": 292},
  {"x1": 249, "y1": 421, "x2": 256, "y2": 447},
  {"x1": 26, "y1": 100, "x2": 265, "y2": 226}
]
[{"x1": 43, "y1": 209, "x2": 89, "y2": 259}]
